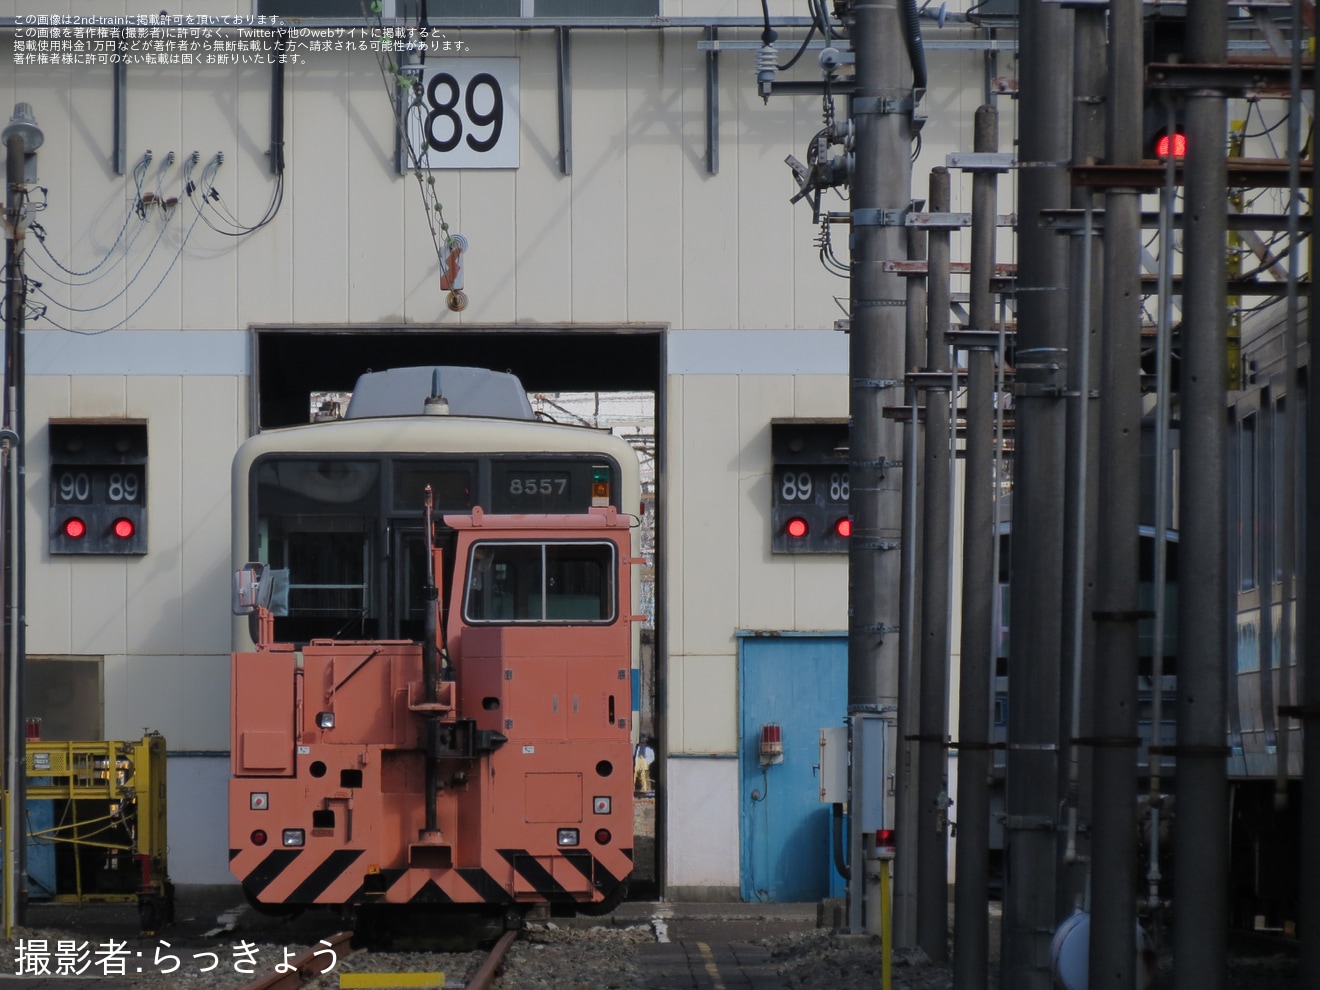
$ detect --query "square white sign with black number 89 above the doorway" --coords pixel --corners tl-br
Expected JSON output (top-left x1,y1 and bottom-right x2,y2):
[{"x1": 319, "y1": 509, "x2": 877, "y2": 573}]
[{"x1": 401, "y1": 58, "x2": 519, "y2": 172}]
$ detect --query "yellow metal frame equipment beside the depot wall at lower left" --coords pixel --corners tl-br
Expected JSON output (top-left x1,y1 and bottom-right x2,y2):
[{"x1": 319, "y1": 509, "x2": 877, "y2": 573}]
[{"x1": 26, "y1": 733, "x2": 174, "y2": 932}]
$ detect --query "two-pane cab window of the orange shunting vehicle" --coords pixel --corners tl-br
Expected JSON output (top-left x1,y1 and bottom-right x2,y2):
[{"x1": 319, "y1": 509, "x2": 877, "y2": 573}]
[{"x1": 463, "y1": 541, "x2": 615, "y2": 624}]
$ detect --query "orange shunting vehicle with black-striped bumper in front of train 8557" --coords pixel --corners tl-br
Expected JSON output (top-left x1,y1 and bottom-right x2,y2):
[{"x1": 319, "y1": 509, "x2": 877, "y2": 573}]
[{"x1": 230, "y1": 510, "x2": 632, "y2": 907}]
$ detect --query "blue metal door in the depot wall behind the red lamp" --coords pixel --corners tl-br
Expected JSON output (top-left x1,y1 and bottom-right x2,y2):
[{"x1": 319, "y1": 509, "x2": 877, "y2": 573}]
[{"x1": 738, "y1": 632, "x2": 847, "y2": 902}]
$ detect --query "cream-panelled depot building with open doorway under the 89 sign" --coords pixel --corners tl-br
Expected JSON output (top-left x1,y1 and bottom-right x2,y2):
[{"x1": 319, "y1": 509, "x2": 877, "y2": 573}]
[{"x1": 0, "y1": 0, "x2": 1015, "y2": 900}]
